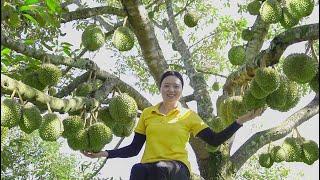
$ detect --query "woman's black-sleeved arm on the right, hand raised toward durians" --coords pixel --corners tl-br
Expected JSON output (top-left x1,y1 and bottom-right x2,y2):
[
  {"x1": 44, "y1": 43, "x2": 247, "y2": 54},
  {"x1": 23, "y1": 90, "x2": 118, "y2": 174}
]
[{"x1": 196, "y1": 109, "x2": 263, "y2": 146}]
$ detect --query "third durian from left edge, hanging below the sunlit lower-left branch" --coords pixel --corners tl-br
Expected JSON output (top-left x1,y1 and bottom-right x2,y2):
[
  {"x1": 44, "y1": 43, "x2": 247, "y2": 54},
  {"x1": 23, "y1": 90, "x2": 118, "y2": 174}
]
[{"x1": 39, "y1": 113, "x2": 63, "y2": 141}]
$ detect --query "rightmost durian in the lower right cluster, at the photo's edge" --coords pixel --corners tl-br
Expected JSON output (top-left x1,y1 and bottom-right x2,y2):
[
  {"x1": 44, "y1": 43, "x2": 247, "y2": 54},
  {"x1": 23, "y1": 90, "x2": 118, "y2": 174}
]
[{"x1": 302, "y1": 140, "x2": 319, "y2": 165}]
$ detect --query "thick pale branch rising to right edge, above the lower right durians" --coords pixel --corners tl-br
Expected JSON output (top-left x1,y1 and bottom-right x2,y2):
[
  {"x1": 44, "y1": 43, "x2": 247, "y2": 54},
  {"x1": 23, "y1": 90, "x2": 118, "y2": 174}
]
[{"x1": 230, "y1": 94, "x2": 319, "y2": 170}]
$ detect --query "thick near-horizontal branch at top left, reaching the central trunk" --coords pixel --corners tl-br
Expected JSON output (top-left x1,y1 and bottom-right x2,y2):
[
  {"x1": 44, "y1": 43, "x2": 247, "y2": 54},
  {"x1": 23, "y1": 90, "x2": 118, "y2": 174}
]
[{"x1": 61, "y1": 6, "x2": 126, "y2": 23}]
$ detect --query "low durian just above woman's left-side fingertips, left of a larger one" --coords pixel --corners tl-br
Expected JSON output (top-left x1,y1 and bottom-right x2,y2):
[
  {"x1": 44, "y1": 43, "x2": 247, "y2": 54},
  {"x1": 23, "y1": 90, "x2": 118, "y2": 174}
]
[{"x1": 67, "y1": 129, "x2": 89, "y2": 151}]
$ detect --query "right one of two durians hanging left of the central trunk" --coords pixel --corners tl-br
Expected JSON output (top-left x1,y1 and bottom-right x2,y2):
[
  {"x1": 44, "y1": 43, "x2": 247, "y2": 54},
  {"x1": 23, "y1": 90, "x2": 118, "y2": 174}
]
[{"x1": 112, "y1": 26, "x2": 134, "y2": 51}]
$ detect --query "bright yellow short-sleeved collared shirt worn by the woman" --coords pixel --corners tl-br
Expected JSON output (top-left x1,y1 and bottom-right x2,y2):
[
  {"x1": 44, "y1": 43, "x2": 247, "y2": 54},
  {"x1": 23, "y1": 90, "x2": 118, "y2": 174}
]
[{"x1": 135, "y1": 103, "x2": 208, "y2": 172}]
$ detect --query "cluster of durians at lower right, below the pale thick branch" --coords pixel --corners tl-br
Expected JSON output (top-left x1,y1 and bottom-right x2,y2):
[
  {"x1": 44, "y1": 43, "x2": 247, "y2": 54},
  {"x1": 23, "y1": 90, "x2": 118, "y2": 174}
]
[{"x1": 259, "y1": 137, "x2": 319, "y2": 168}]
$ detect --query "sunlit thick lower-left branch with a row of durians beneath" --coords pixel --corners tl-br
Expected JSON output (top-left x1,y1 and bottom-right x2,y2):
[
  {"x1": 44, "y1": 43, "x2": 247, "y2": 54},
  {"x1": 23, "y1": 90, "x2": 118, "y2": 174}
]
[{"x1": 1, "y1": 74, "x2": 98, "y2": 113}]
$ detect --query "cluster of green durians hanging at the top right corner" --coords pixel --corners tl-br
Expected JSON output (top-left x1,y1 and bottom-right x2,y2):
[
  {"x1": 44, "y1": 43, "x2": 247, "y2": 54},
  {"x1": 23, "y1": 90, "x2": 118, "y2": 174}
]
[{"x1": 247, "y1": 0, "x2": 315, "y2": 29}]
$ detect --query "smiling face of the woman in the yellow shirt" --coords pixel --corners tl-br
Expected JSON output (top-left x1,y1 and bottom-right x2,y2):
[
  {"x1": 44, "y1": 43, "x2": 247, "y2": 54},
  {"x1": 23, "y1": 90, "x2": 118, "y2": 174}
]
[{"x1": 160, "y1": 76, "x2": 182, "y2": 102}]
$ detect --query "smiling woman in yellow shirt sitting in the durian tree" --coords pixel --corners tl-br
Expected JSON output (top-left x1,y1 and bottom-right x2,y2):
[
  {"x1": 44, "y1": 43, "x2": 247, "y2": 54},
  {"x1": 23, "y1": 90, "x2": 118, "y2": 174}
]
[{"x1": 83, "y1": 71, "x2": 260, "y2": 180}]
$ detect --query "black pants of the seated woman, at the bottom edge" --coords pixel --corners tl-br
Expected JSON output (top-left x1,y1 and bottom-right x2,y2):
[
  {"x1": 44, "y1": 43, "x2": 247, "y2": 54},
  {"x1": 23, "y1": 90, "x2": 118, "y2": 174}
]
[{"x1": 130, "y1": 161, "x2": 190, "y2": 180}]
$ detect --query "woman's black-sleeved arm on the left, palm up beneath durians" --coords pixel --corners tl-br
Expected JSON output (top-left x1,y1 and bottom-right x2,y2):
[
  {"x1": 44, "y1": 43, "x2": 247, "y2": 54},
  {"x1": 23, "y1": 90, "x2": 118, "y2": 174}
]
[{"x1": 82, "y1": 132, "x2": 146, "y2": 158}]
